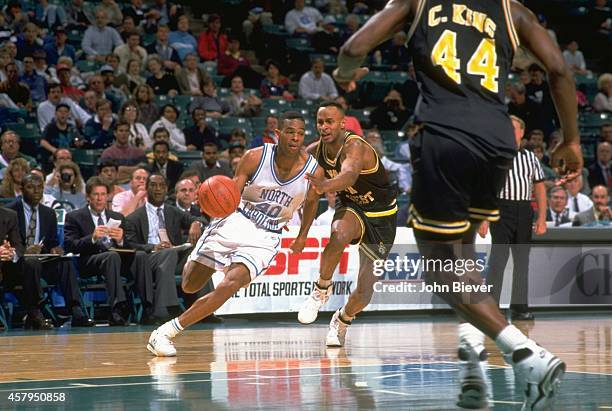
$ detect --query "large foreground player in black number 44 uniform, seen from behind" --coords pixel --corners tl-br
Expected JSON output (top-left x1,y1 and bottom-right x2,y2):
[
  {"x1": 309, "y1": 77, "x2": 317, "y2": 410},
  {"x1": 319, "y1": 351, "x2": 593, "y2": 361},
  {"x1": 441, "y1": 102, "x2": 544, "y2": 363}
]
[{"x1": 334, "y1": 0, "x2": 582, "y2": 410}]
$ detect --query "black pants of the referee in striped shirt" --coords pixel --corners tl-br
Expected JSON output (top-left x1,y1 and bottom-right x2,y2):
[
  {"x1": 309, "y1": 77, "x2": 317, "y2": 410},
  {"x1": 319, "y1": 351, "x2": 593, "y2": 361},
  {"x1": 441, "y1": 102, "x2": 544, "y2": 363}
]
[{"x1": 487, "y1": 200, "x2": 533, "y2": 312}]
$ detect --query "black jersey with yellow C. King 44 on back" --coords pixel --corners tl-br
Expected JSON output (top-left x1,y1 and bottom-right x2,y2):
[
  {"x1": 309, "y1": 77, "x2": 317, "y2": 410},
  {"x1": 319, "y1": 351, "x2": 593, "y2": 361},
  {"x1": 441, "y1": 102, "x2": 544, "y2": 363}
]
[{"x1": 409, "y1": 0, "x2": 518, "y2": 157}]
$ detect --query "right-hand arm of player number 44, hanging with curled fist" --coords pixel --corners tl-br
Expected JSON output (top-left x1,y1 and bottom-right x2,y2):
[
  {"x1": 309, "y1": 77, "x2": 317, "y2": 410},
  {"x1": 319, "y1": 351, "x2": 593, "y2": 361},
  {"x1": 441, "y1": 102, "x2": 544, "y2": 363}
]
[{"x1": 512, "y1": 1, "x2": 583, "y2": 178}]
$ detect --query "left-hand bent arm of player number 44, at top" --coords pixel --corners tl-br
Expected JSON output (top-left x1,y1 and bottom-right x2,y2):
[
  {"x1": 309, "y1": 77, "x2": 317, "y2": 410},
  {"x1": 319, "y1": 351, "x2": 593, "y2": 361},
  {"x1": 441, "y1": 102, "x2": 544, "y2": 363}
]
[{"x1": 334, "y1": 0, "x2": 418, "y2": 91}]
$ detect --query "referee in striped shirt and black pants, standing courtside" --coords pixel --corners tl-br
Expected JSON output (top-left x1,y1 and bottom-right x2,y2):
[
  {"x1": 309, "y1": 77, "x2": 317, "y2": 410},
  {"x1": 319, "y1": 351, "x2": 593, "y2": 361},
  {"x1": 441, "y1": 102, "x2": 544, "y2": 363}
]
[{"x1": 478, "y1": 116, "x2": 546, "y2": 321}]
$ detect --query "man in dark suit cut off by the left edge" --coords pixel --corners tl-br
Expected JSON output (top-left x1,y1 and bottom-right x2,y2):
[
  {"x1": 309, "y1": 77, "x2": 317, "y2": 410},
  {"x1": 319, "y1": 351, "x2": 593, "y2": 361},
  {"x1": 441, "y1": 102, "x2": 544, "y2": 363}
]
[{"x1": 0, "y1": 207, "x2": 53, "y2": 330}]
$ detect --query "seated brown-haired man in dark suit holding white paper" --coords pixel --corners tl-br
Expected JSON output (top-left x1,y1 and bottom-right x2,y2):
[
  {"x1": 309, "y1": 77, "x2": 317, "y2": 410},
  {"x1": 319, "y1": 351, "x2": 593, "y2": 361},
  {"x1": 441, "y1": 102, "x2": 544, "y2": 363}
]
[{"x1": 64, "y1": 177, "x2": 153, "y2": 325}]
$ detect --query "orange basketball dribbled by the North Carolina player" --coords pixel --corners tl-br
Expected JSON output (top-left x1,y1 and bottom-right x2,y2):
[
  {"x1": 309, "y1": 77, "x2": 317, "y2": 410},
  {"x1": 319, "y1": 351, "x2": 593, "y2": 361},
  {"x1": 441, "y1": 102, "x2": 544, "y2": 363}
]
[{"x1": 198, "y1": 176, "x2": 240, "y2": 218}]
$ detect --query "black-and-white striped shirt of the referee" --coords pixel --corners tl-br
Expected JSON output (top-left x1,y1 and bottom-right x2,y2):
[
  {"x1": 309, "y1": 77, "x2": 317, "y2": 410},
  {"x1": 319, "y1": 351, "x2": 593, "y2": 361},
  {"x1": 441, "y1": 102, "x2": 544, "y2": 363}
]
[{"x1": 497, "y1": 149, "x2": 544, "y2": 201}]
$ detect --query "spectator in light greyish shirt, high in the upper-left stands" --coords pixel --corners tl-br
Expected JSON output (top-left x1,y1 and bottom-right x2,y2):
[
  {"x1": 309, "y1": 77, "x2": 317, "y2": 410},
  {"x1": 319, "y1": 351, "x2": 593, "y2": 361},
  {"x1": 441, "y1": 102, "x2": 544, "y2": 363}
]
[{"x1": 81, "y1": 8, "x2": 123, "y2": 61}]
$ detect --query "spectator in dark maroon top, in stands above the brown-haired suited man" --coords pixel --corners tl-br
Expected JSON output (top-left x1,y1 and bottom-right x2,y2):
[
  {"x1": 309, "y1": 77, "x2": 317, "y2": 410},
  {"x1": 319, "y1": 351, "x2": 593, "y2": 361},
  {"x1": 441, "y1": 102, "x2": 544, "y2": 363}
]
[{"x1": 101, "y1": 120, "x2": 147, "y2": 181}]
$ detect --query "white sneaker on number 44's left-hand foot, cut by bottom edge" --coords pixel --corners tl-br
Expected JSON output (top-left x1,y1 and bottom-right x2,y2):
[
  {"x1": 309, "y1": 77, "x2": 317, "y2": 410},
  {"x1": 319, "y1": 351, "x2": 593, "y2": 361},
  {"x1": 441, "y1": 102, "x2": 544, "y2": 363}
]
[{"x1": 457, "y1": 342, "x2": 489, "y2": 409}]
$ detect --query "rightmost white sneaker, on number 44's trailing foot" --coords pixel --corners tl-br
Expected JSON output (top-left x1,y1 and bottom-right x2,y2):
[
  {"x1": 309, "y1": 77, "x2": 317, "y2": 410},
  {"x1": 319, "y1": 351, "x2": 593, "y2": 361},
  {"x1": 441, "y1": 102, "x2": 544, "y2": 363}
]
[{"x1": 504, "y1": 340, "x2": 565, "y2": 411}]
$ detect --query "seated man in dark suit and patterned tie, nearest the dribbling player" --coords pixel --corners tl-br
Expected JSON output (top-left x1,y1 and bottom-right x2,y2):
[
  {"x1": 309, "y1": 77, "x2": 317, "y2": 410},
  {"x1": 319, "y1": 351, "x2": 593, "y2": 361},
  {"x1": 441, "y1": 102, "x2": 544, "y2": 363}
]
[{"x1": 126, "y1": 174, "x2": 201, "y2": 321}]
